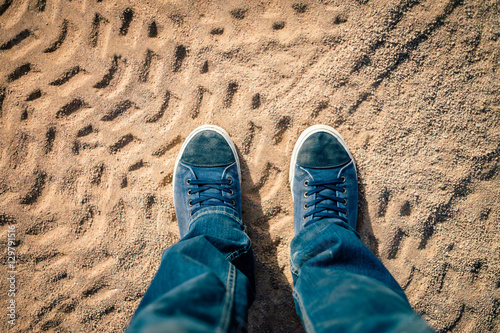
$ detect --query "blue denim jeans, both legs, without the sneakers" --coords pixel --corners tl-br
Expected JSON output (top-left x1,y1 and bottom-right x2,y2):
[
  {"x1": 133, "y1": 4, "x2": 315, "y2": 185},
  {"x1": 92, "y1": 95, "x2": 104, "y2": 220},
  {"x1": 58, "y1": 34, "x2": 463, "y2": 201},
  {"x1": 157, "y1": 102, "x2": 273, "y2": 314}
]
[{"x1": 127, "y1": 207, "x2": 433, "y2": 333}]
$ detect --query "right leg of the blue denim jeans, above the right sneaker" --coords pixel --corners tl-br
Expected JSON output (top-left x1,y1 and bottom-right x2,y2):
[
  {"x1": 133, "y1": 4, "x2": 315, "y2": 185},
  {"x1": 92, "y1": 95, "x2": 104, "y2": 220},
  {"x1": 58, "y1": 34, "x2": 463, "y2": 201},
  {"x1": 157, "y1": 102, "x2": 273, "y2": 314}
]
[{"x1": 290, "y1": 219, "x2": 433, "y2": 333}]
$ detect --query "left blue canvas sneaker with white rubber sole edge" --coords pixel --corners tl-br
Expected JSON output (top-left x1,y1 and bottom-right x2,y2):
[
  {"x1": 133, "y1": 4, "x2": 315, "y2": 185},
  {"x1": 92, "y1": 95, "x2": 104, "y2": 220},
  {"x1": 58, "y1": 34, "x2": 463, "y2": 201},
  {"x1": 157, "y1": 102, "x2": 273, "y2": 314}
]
[{"x1": 173, "y1": 125, "x2": 241, "y2": 238}]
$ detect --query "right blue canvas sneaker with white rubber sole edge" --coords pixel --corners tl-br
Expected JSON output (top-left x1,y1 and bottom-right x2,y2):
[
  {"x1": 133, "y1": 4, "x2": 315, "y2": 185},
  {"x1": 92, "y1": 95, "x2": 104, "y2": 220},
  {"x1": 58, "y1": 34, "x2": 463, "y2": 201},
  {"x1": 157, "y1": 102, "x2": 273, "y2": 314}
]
[{"x1": 289, "y1": 125, "x2": 358, "y2": 234}]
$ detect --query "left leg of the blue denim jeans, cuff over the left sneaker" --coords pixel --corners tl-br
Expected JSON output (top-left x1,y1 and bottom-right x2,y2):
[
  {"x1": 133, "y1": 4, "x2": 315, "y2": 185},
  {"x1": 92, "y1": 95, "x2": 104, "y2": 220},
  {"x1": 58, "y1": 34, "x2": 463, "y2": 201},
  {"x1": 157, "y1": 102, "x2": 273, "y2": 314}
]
[{"x1": 127, "y1": 207, "x2": 254, "y2": 332}]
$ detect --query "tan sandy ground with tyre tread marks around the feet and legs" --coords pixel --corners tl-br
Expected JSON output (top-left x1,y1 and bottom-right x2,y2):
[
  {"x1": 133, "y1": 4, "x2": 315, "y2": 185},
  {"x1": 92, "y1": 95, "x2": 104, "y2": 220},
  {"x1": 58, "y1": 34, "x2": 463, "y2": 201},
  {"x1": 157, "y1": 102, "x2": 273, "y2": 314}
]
[{"x1": 0, "y1": 0, "x2": 500, "y2": 332}]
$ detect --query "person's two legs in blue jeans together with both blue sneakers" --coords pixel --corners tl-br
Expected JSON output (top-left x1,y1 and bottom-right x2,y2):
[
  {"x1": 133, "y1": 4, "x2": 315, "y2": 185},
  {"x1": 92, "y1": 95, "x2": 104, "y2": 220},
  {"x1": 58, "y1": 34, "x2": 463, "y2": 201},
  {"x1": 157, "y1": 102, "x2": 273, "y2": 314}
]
[{"x1": 127, "y1": 125, "x2": 432, "y2": 332}]
